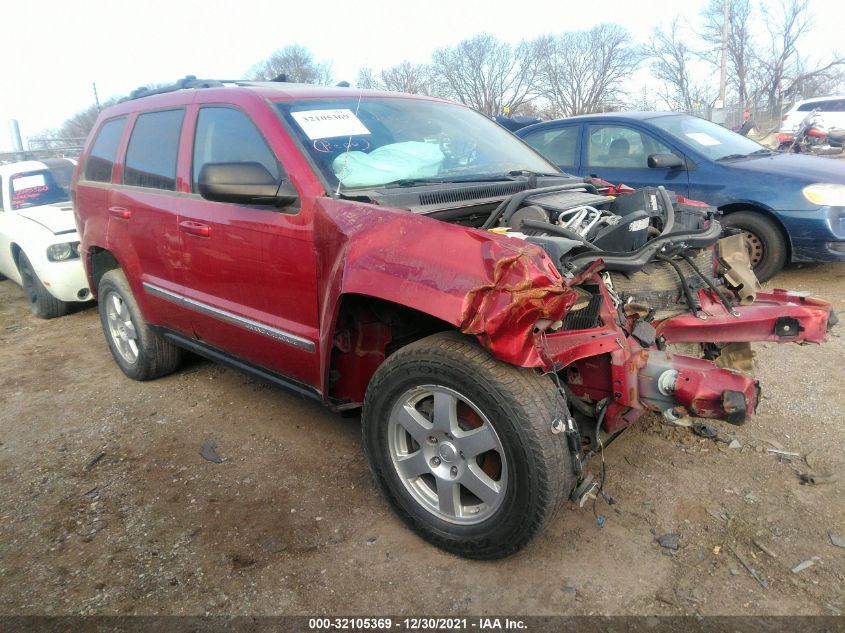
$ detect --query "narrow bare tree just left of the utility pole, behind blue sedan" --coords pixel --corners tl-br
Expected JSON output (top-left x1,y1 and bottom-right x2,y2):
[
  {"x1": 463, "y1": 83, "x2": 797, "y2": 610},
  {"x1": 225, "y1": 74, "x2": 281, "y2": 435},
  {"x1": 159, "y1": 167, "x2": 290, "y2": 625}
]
[{"x1": 649, "y1": 17, "x2": 712, "y2": 111}]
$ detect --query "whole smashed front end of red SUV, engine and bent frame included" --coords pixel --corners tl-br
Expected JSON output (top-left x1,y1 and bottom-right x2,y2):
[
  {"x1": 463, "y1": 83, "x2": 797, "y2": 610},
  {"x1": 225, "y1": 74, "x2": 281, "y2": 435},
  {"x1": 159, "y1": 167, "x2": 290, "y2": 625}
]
[{"x1": 462, "y1": 178, "x2": 835, "y2": 434}]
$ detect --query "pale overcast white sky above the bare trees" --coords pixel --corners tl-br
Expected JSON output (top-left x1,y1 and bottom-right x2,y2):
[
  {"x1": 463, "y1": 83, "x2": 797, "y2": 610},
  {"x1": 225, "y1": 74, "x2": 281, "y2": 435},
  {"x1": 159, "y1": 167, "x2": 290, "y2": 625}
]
[{"x1": 0, "y1": 0, "x2": 845, "y2": 151}]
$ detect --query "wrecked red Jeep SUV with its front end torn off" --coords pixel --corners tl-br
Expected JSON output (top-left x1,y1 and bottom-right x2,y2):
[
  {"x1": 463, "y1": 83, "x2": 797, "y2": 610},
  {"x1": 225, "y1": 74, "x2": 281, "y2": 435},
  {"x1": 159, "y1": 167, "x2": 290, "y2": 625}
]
[{"x1": 72, "y1": 77, "x2": 831, "y2": 558}]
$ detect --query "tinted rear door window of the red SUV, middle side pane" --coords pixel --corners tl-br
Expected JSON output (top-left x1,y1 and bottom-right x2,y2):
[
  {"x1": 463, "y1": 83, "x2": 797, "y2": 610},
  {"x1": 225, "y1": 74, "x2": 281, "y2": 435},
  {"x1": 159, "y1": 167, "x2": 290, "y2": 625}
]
[{"x1": 123, "y1": 110, "x2": 185, "y2": 191}]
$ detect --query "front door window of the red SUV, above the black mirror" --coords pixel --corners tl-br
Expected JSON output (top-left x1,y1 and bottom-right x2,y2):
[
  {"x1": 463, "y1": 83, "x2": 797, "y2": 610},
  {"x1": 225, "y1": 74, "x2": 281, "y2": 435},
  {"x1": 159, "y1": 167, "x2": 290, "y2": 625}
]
[{"x1": 193, "y1": 107, "x2": 281, "y2": 191}]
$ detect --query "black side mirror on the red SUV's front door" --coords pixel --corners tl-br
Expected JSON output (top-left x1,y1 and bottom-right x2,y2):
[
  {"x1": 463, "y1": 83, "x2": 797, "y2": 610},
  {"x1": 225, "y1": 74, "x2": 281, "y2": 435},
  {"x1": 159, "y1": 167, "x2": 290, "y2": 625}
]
[{"x1": 197, "y1": 162, "x2": 299, "y2": 207}]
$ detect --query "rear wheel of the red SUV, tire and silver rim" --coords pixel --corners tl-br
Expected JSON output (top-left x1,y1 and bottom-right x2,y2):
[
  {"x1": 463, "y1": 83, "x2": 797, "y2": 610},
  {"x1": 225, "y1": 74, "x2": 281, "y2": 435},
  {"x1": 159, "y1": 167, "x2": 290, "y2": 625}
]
[{"x1": 97, "y1": 269, "x2": 182, "y2": 380}]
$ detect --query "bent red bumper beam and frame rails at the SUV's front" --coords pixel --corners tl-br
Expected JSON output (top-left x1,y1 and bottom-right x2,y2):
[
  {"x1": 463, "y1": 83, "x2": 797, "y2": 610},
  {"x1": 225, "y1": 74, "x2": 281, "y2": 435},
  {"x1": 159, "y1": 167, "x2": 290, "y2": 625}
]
[{"x1": 537, "y1": 280, "x2": 837, "y2": 433}]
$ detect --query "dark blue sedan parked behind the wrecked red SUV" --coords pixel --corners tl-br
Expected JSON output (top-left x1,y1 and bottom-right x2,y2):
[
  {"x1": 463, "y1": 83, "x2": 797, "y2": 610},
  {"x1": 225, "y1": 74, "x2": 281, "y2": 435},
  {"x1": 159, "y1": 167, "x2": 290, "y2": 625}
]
[{"x1": 515, "y1": 112, "x2": 845, "y2": 281}]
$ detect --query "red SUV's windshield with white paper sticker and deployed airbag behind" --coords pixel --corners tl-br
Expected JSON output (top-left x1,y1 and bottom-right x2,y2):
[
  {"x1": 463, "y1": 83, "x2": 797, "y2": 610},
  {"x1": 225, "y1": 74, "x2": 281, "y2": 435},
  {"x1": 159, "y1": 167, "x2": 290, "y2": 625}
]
[{"x1": 276, "y1": 97, "x2": 559, "y2": 189}]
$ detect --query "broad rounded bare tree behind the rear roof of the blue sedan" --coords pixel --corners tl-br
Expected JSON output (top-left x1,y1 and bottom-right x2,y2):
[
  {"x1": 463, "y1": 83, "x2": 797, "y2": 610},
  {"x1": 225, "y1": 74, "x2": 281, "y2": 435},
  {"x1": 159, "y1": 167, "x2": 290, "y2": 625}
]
[{"x1": 533, "y1": 24, "x2": 643, "y2": 116}]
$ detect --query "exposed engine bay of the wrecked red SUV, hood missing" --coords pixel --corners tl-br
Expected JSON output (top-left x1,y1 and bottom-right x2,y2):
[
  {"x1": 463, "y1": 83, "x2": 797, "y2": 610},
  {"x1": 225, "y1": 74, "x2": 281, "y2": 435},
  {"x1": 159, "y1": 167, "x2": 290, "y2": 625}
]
[{"x1": 474, "y1": 178, "x2": 759, "y2": 329}]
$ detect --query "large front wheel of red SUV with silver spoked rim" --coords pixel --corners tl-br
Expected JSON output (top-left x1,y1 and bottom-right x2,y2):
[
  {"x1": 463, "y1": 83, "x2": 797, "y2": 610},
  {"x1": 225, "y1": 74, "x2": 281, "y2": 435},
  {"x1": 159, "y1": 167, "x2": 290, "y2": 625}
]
[{"x1": 362, "y1": 333, "x2": 575, "y2": 559}]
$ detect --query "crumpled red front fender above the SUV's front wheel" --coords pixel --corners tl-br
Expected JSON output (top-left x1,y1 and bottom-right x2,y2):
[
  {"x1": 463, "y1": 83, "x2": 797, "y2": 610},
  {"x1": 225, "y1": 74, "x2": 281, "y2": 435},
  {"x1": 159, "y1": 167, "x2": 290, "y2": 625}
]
[{"x1": 315, "y1": 199, "x2": 576, "y2": 367}]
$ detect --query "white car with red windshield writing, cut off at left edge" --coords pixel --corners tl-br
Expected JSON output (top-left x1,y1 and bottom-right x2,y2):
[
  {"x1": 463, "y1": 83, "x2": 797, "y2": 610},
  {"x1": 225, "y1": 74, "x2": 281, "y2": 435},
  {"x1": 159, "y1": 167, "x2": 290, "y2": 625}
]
[{"x1": 0, "y1": 158, "x2": 92, "y2": 319}]
